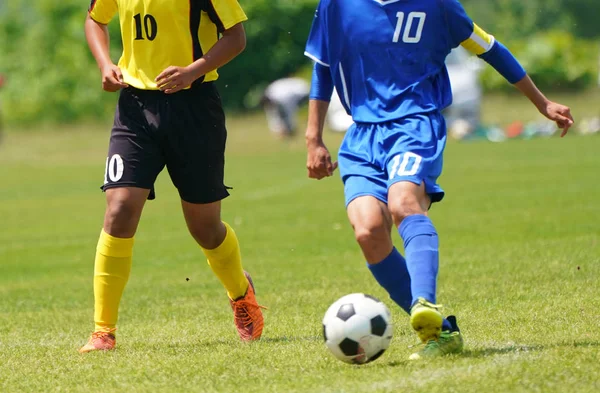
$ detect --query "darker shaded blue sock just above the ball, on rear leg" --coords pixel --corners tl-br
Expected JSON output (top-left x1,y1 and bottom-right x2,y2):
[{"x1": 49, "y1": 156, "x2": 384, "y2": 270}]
[{"x1": 367, "y1": 247, "x2": 412, "y2": 314}]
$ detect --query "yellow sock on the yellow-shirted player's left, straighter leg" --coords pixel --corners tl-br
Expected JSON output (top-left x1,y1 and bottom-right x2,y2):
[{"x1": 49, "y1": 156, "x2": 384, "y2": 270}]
[{"x1": 94, "y1": 230, "x2": 133, "y2": 331}]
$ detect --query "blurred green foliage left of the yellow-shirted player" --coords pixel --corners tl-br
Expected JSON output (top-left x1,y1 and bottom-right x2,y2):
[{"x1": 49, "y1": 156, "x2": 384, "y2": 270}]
[{"x1": 0, "y1": 0, "x2": 120, "y2": 123}]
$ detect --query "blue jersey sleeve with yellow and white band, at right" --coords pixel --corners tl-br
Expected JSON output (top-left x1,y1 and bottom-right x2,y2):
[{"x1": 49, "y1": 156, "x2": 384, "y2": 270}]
[{"x1": 443, "y1": 0, "x2": 494, "y2": 56}]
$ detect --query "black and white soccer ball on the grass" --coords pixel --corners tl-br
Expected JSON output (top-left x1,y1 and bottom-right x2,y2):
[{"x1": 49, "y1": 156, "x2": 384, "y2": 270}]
[{"x1": 323, "y1": 293, "x2": 393, "y2": 364}]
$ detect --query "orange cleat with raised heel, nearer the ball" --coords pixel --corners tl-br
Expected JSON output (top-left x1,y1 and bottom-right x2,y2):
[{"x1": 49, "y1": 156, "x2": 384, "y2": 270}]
[{"x1": 229, "y1": 272, "x2": 266, "y2": 341}]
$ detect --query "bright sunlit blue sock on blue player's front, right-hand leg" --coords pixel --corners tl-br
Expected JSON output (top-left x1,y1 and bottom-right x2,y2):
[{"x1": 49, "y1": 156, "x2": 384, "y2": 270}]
[{"x1": 398, "y1": 214, "x2": 439, "y2": 303}]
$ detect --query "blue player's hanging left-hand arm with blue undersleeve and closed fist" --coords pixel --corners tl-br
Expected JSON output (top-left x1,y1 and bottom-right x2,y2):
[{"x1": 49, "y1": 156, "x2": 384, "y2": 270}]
[{"x1": 306, "y1": 63, "x2": 337, "y2": 180}]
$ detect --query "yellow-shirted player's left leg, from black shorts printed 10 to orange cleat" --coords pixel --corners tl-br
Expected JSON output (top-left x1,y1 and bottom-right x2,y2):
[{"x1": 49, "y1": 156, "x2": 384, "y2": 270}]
[{"x1": 80, "y1": 91, "x2": 164, "y2": 353}]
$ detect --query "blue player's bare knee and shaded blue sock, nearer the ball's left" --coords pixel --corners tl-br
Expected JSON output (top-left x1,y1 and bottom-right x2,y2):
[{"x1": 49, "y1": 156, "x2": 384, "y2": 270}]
[{"x1": 347, "y1": 196, "x2": 412, "y2": 313}]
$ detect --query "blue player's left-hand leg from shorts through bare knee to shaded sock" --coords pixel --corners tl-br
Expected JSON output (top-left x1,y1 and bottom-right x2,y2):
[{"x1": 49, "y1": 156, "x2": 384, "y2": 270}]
[{"x1": 338, "y1": 125, "x2": 412, "y2": 312}]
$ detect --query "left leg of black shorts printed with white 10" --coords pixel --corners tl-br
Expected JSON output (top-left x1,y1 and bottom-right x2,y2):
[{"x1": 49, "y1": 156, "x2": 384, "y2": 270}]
[{"x1": 102, "y1": 88, "x2": 165, "y2": 191}]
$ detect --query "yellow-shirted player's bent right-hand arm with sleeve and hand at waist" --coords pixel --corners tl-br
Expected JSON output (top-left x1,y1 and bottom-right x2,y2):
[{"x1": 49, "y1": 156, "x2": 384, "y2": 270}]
[{"x1": 156, "y1": 0, "x2": 248, "y2": 93}]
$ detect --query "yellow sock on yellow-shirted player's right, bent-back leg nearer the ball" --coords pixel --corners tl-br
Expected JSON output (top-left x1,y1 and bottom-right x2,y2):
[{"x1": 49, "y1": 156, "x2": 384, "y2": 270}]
[{"x1": 202, "y1": 222, "x2": 249, "y2": 299}]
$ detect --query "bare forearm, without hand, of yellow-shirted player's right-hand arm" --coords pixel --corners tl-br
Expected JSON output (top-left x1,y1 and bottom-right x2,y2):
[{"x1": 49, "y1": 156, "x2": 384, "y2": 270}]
[{"x1": 190, "y1": 23, "x2": 246, "y2": 78}]
